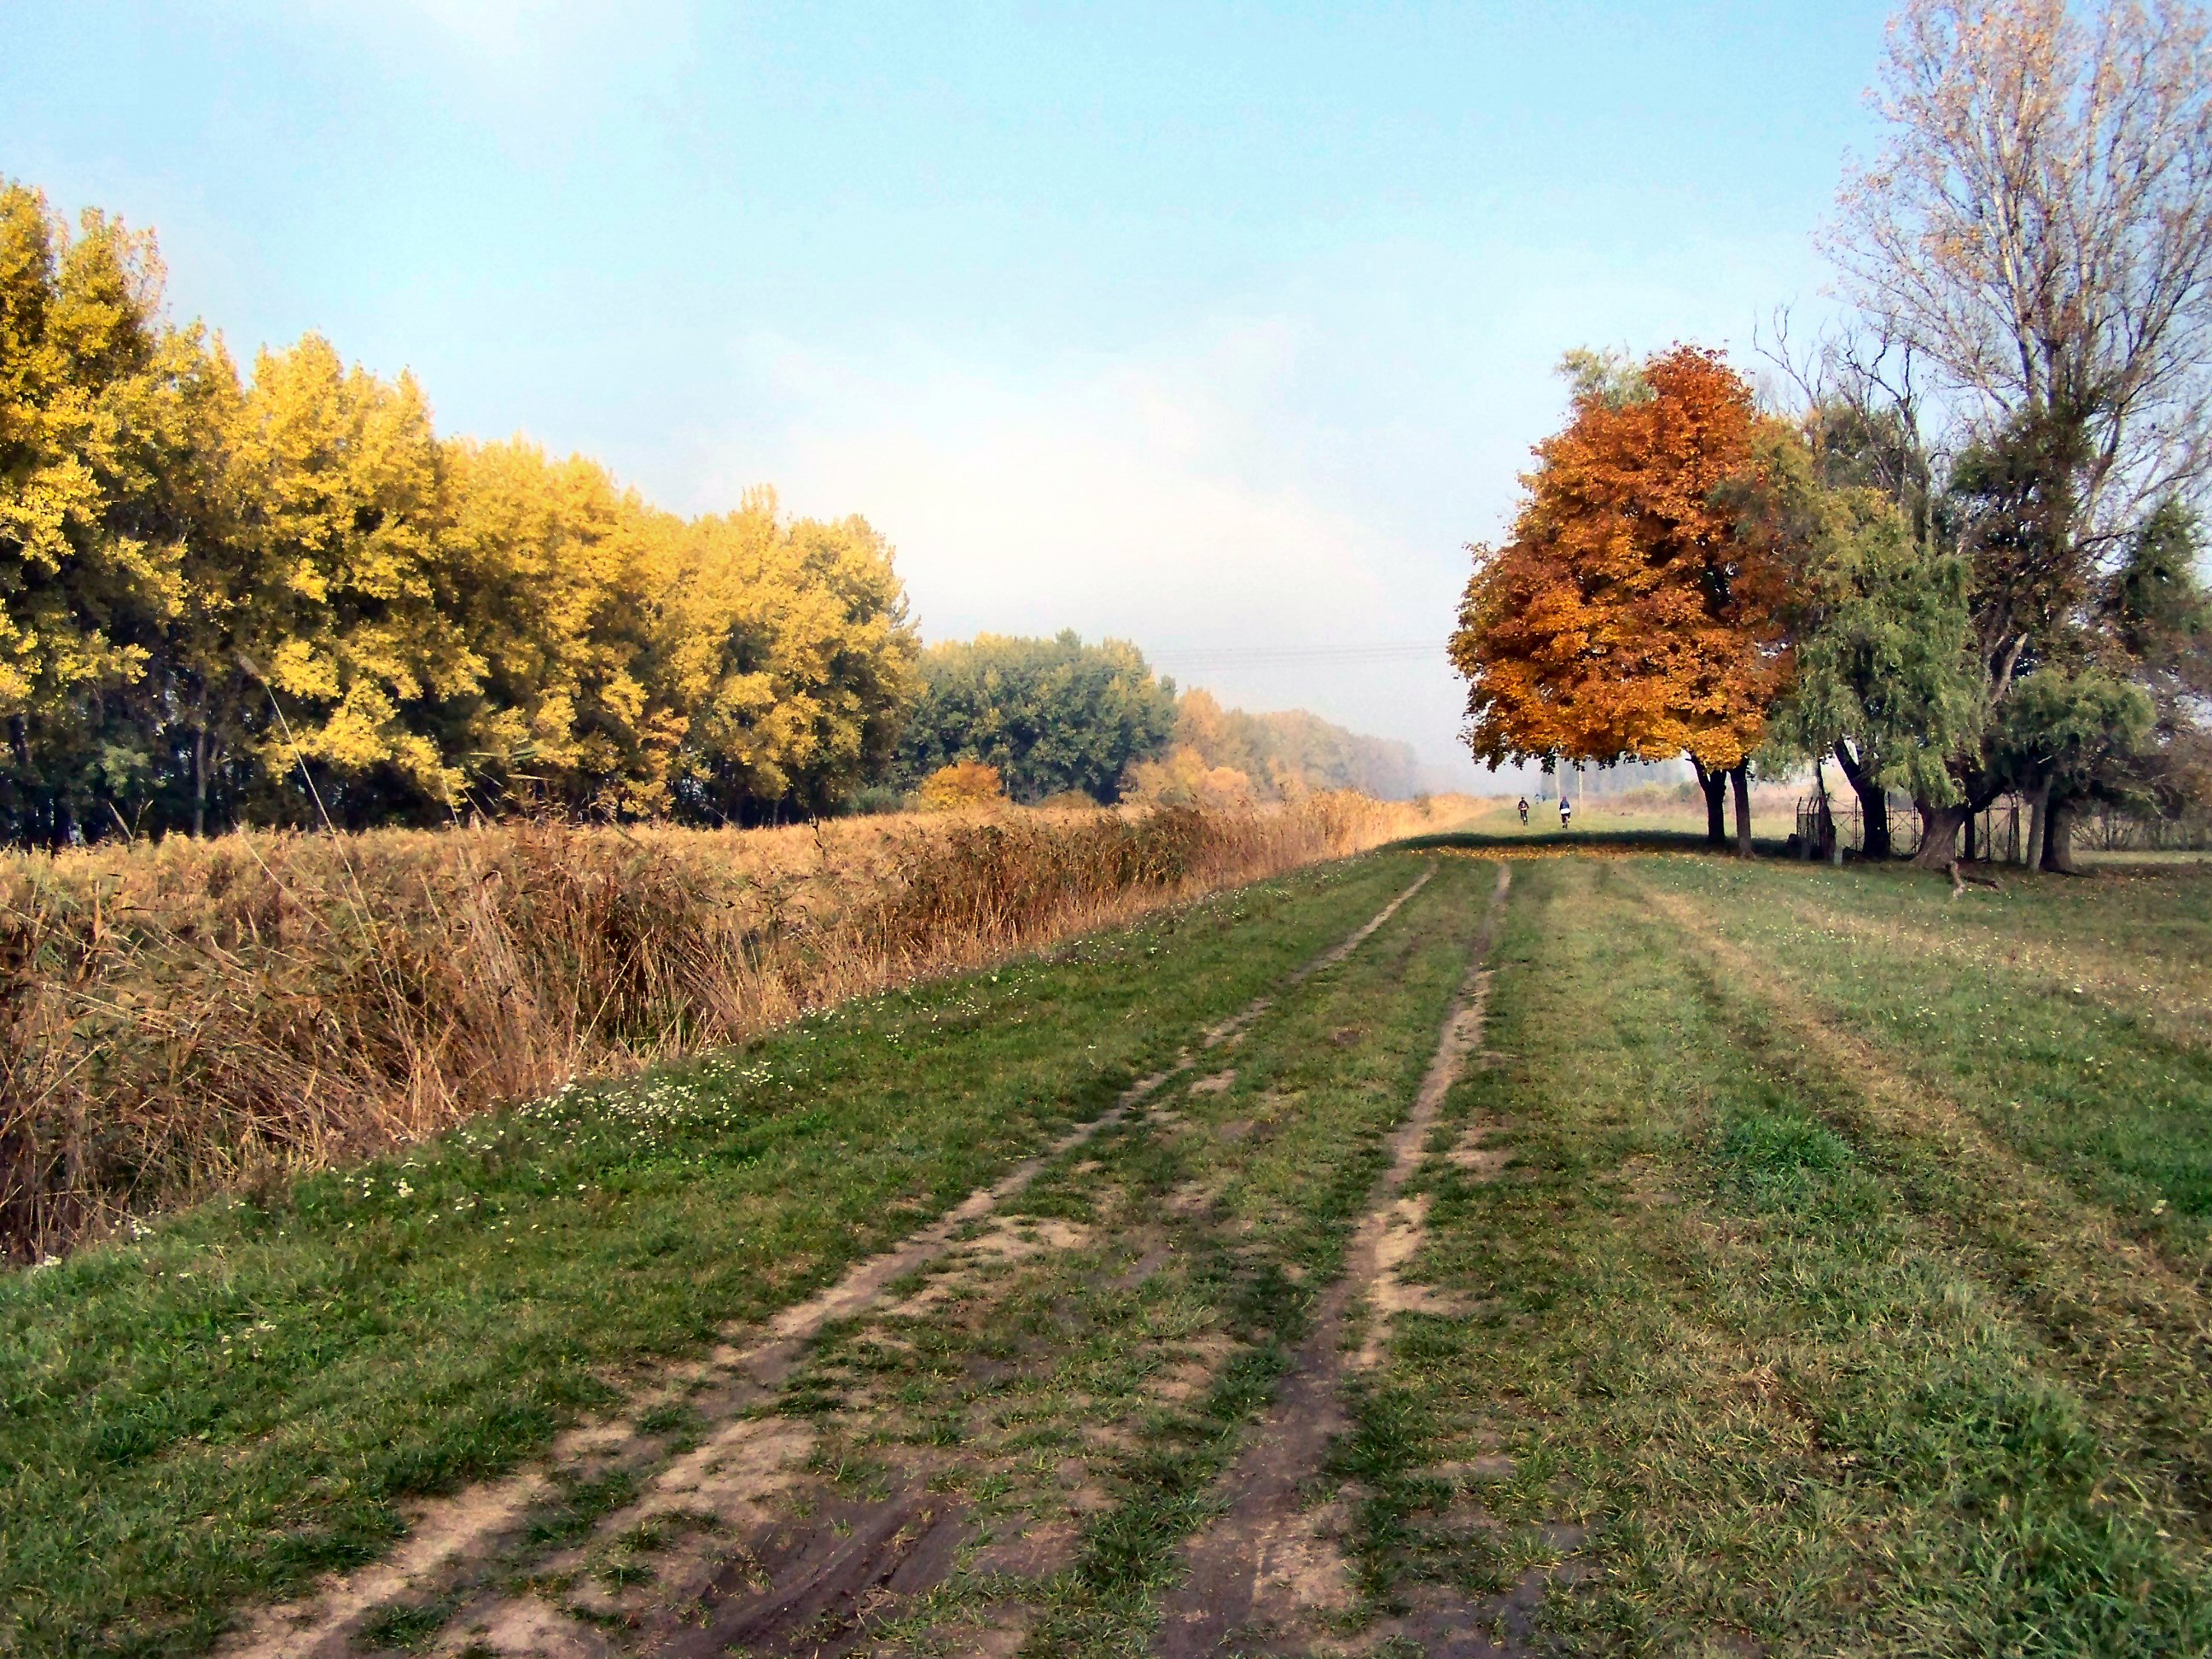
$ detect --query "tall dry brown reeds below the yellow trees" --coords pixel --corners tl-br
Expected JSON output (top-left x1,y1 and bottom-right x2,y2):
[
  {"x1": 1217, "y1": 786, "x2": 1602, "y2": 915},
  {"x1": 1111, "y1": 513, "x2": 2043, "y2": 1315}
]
[{"x1": 0, "y1": 795, "x2": 1438, "y2": 1260}]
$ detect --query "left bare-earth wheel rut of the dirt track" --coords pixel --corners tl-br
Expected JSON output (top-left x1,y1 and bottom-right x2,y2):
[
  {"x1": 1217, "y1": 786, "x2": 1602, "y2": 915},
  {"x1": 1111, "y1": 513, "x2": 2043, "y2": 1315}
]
[{"x1": 217, "y1": 860, "x2": 1433, "y2": 1659}]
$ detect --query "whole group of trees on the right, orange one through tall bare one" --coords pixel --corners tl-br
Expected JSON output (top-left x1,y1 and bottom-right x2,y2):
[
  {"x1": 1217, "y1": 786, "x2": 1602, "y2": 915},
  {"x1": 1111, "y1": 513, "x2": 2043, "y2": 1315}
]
[{"x1": 1451, "y1": 0, "x2": 2212, "y2": 867}]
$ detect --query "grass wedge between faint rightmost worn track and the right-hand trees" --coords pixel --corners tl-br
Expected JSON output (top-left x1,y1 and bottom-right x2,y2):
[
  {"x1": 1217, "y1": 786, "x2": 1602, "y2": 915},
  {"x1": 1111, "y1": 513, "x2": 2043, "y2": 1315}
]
[{"x1": 1650, "y1": 864, "x2": 2212, "y2": 1263}]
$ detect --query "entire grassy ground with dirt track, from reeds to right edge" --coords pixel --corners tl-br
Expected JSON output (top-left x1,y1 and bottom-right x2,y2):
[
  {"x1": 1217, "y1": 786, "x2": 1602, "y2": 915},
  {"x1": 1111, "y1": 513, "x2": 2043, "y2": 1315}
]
[{"x1": 0, "y1": 825, "x2": 2212, "y2": 1659}]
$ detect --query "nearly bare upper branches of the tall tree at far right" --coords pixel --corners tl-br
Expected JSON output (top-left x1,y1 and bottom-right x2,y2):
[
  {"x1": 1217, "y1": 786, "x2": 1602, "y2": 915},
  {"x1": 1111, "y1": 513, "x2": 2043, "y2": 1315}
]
[{"x1": 1825, "y1": 0, "x2": 2212, "y2": 556}]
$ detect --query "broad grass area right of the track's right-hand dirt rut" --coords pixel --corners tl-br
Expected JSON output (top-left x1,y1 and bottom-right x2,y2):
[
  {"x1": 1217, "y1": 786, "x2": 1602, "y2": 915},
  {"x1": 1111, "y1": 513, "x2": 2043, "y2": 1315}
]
[{"x1": 1345, "y1": 860, "x2": 2212, "y2": 1655}]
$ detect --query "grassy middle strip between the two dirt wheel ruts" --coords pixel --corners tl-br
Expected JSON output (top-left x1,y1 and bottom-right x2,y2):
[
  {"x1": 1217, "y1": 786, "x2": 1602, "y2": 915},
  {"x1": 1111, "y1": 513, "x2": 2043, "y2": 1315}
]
[{"x1": 805, "y1": 860, "x2": 1488, "y2": 1659}]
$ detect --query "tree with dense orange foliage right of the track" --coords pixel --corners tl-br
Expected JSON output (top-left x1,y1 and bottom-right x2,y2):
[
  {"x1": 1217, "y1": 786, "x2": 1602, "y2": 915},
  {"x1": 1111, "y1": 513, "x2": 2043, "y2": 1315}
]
[{"x1": 1451, "y1": 345, "x2": 1790, "y2": 838}]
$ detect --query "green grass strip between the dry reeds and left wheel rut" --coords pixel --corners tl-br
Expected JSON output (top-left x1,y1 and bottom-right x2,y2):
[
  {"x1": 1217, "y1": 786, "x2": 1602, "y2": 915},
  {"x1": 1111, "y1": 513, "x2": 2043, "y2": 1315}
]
[{"x1": 0, "y1": 859, "x2": 1413, "y2": 1655}]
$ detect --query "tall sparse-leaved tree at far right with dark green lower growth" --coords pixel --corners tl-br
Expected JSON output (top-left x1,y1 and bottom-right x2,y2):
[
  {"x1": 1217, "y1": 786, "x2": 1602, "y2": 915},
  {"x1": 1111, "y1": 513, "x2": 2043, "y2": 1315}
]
[{"x1": 1816, "y1": 0, "x2": 2212, "y2": 867}]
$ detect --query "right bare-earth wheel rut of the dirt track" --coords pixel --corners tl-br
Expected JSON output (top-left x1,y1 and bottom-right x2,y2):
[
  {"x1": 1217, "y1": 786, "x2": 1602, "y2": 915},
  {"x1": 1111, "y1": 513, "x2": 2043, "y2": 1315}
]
[{"x1": 1159, "y1": 867, "x2": 1511, "y2": 1659}]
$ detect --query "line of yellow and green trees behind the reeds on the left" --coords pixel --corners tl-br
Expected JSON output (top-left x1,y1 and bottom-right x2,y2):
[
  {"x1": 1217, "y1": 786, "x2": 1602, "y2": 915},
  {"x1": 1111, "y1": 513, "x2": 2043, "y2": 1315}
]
[{"x1": 0, "y1": 182, "x2": 1413, "y2": 845}]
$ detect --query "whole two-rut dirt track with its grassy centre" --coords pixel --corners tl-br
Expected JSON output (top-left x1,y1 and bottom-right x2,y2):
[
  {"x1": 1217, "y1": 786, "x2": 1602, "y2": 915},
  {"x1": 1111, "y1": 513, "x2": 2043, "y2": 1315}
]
[{"x1": 225, "y1": 860, "x2": 1540, "y2": 1659}]
